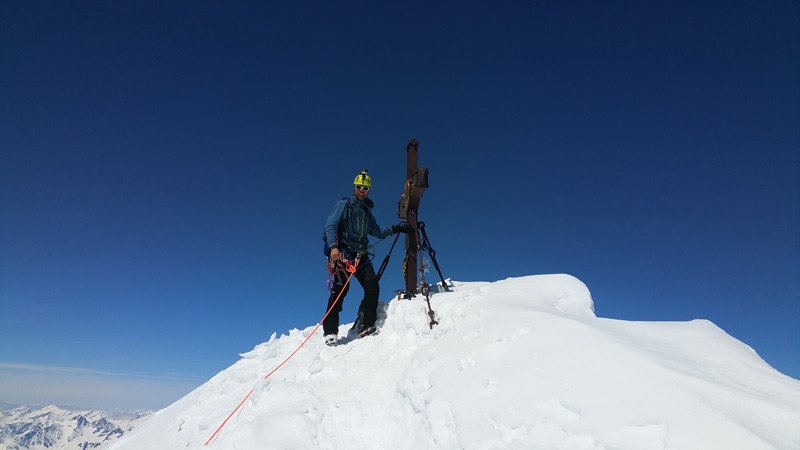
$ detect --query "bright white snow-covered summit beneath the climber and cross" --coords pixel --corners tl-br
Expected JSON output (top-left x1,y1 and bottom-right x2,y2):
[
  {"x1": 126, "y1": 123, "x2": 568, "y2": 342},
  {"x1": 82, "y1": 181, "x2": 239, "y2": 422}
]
[{"x1": 111, "y1": 275, "x2": 800, "y2": 450}]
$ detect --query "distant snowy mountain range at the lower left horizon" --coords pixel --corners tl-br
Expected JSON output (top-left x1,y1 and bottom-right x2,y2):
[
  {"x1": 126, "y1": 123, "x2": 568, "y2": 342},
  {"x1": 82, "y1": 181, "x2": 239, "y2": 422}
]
[{"x1": 0, "y1": 405, "x2": 147, "y2": 450}]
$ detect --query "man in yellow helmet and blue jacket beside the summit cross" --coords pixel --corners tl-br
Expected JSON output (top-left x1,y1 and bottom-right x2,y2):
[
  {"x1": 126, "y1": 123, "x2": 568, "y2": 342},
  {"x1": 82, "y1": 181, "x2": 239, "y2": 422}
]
[{"x1": 322, "y1": 170, "x2": 413, "y2": 346}]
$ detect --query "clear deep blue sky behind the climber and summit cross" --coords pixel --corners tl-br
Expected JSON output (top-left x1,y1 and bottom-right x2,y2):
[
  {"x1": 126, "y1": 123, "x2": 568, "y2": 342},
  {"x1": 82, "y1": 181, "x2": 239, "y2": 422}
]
[{"x1": 0, "y1": 0, "x2": 800, "y2": 407}]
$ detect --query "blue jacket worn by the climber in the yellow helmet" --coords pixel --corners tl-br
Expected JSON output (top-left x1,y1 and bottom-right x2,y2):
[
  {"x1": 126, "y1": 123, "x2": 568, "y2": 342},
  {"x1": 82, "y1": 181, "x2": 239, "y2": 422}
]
[{"x1": 325, "y1": 196, "x2": 392, "y2": 253}]
